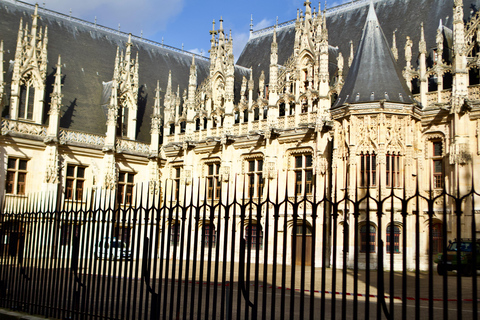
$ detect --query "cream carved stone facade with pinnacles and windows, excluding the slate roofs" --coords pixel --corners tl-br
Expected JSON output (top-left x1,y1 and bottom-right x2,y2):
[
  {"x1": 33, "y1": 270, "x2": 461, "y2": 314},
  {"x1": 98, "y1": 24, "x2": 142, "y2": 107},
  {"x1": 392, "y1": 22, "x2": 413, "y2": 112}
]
[{"x1": 0, "y1": 0, "x2": 480, "y2": 267}]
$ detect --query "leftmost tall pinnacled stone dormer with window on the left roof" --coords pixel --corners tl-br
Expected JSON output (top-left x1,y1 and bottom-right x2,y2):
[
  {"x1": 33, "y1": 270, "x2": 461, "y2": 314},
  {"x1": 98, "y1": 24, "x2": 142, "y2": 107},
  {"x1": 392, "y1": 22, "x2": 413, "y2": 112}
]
[{"x1": 10, "y1": 5, "x2": 48, "y2": 124}]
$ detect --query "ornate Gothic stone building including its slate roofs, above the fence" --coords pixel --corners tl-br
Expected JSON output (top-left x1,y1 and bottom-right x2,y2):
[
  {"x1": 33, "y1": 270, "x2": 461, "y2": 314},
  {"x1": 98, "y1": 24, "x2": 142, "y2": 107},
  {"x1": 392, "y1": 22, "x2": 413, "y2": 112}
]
[{"x1": 0, "y1": 0, "x2": 480, "y2": 268}]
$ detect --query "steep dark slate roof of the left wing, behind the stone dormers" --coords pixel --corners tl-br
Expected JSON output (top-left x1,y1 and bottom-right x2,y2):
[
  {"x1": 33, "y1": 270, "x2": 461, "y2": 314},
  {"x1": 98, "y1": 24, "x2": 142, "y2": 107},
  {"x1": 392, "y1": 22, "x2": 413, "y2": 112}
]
[{"x1": 0, "y1": 0, "x2": 218, "y2": 142}]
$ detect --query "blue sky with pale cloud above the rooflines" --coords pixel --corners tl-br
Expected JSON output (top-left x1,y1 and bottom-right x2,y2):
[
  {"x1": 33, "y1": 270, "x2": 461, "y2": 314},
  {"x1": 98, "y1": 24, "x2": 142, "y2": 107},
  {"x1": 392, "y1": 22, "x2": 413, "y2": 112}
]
[{"x1": 23, "y1": 0, "x2": 351, "y2": 59}]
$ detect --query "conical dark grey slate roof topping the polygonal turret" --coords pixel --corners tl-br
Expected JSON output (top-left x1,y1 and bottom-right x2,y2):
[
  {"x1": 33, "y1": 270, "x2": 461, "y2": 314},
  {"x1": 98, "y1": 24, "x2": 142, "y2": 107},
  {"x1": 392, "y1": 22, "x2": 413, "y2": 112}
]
[{"x1": 334, "y1": 3, "x2": 413, "y2": 107}]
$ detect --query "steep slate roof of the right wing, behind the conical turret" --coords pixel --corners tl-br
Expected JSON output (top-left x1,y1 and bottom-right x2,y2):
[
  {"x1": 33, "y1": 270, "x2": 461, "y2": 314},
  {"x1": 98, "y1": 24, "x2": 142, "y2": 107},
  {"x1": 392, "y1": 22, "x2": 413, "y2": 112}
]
[{"x1": 237, "y1": 0, "x2": 480, "y2": 100}]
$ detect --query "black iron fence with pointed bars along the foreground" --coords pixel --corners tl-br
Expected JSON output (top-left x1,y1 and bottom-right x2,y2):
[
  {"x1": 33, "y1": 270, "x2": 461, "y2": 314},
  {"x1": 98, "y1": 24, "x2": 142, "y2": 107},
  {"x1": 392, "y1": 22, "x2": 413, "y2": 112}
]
[{"x1": 0, "y1": 181, "x2": 480, "y2": 319}]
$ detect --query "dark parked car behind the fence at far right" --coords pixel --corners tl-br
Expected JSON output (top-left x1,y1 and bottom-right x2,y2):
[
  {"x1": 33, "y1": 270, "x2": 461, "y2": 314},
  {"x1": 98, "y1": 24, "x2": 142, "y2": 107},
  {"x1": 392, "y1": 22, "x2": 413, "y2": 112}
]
[{"x1": 434, "y1": 239, "x2": 480, "y2": 276}]
